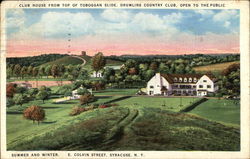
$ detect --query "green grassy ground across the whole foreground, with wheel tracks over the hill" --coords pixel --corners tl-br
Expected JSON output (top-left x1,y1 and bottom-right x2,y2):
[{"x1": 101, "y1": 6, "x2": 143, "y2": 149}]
[{"x1": 7, "y1": 87, "x2": 240, "y2": 151}]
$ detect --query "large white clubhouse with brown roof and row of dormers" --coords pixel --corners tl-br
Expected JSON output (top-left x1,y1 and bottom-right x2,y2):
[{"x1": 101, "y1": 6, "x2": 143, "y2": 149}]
[{"x1": 147, "y1": 73, "x2": 218, "y2": 96}]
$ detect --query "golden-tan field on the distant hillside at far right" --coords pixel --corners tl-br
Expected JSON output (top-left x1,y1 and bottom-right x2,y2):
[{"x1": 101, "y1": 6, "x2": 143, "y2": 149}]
[{"x1": 194, "y1": 61, "x2": 240, "y2": 72}]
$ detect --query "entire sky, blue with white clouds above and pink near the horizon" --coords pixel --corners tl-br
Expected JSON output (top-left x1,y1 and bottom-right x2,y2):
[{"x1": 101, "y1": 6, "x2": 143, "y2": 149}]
[{"x1": 6, "y1": 9, "x2": 240, "y2": 57}]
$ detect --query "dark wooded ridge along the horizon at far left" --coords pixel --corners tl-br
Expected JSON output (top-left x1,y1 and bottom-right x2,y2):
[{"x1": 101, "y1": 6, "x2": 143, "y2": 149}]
[{"x1": 6, "y1": 54, "x2": 69, "y2": 66}]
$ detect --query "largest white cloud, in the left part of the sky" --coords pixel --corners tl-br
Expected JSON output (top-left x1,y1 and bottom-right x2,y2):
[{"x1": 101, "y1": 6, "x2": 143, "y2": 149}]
[{"x1": 11, "y1": 12, "x2": 95, "y2": 38}]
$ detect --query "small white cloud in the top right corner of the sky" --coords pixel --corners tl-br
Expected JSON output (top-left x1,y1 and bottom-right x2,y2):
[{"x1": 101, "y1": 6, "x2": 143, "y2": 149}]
[{"x1": 213, "y1": 9, "x2": 239, "y2": 22}]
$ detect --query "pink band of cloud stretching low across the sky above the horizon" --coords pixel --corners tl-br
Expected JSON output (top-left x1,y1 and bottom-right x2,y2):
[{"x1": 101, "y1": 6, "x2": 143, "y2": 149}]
[{"x1": 7, "y1": 33, "x2": 239, "y2": 57}]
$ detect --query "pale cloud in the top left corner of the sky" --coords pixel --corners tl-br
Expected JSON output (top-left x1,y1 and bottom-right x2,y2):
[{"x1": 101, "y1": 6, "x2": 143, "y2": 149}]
[{"x1": 6, "y1": 9, "x2": 25, "y2": 29}]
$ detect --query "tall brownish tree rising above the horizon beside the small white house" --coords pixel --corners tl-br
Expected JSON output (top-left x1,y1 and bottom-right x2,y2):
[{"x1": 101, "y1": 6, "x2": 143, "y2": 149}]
[{"x1": 91, "y1": 52, "x2": 106, "y2": 73}]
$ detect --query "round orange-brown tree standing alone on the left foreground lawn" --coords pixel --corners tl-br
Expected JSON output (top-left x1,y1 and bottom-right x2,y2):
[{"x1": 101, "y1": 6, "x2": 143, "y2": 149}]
[{"x1": 23, "y1": 105, "x2": 45, "y2": 124}]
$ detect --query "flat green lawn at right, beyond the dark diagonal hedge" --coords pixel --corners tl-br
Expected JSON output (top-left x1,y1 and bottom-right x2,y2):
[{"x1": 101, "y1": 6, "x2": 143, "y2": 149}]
[{"x1": 189, "y1": 99, "x2": 240, "y2": 125}]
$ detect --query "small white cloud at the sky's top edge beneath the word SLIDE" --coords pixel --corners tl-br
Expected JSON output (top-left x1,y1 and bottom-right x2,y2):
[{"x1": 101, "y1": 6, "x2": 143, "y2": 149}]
[{"x1": 101, "y1": 9, "x2": 131, "y2": 22}]
